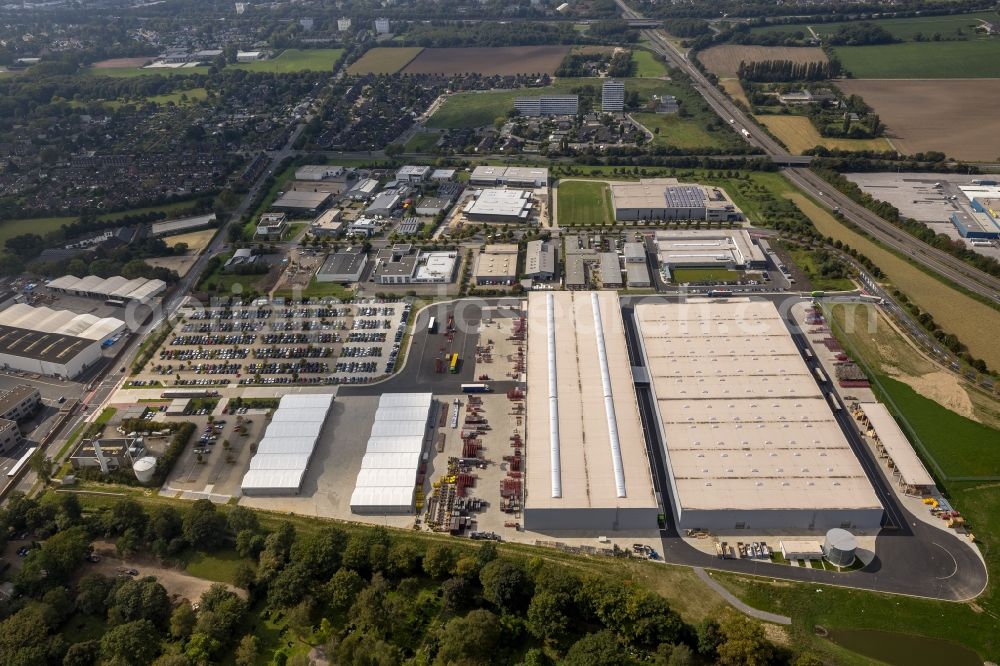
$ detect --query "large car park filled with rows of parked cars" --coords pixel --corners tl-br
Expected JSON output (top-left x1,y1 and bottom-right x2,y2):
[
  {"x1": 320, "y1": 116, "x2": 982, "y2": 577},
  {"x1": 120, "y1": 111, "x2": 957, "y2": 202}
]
[{"x1": 129, "y1": 300, "x2": 410, "y2": 387}]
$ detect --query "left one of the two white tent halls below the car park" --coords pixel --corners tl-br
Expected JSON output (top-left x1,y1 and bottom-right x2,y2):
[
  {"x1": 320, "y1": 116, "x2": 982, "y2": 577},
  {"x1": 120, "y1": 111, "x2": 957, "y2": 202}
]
[{"x1": 241, "y1": 393, "x2": 333, "y2": 495}]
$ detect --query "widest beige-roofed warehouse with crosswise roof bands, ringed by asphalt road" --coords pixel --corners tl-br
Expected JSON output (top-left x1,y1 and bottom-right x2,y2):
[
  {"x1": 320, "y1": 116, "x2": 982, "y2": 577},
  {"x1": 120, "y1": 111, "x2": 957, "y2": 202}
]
[{"x1": 635, "y1": 299, "x2": 883, "y2": 531}]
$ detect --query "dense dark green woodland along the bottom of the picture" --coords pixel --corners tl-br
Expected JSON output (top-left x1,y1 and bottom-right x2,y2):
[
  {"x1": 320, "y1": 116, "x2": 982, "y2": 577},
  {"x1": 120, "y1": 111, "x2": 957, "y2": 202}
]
[{"x1": 0, "y1": 492, "x2": 818, "y2": 666}]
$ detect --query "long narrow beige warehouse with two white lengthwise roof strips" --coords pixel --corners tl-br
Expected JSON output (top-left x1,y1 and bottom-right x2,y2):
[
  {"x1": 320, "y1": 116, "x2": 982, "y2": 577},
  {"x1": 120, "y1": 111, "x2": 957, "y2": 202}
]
[{"x1": 524, "y1": 292, "x2": 660, "y2": 533}]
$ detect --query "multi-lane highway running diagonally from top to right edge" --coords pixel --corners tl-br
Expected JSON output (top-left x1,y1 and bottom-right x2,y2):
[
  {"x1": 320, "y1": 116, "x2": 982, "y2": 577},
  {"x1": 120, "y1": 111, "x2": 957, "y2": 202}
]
[{"x1": 616, "y1": 0, "x2": 1000, "y2": 302}]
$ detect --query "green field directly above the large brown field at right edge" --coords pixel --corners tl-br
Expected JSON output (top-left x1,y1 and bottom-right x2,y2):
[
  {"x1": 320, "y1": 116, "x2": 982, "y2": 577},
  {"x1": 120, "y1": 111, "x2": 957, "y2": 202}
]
[{"x1": 833, "y1": 39, "x2": 1000, "y2": 79}]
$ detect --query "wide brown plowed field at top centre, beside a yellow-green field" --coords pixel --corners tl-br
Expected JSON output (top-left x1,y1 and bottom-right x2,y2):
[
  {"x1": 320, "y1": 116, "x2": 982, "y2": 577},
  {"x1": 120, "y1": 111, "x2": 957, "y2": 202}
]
[{"x1": 403, "y1": 46, "x2": 569, "y2": 76}]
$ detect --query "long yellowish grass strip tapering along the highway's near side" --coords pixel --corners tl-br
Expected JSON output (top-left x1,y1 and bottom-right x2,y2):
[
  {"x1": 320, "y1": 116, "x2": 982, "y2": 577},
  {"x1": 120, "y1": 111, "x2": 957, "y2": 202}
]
[{"x1": 786, "y1": 192, "x2": 1000, "y2": 368}]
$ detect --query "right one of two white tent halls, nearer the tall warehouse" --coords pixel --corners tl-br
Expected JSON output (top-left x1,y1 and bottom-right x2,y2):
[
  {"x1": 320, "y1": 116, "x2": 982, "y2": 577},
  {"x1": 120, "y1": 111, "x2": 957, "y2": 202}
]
[{"x1": 351, "y1": 393, "x2": 432, "y2": 514}]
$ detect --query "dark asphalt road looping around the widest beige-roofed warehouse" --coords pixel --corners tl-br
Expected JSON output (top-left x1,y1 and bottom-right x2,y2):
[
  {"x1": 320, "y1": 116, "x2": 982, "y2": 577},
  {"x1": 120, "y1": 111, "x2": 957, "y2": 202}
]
[{"x1": 624, "y1": 298, "x2": 987, "y2": 601}]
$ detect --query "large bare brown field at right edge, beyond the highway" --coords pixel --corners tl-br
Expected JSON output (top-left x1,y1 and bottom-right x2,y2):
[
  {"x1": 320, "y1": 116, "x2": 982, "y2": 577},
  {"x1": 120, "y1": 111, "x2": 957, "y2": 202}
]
[{"x1": 837, "y1": 79, "x2": 1000, "y2": 162}]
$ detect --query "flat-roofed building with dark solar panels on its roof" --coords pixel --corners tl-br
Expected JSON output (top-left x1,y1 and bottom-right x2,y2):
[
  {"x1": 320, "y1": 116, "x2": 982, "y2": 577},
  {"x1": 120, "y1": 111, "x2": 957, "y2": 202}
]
[{"x1": 611, "y1": 178, "x2": 743, "y2": 222}]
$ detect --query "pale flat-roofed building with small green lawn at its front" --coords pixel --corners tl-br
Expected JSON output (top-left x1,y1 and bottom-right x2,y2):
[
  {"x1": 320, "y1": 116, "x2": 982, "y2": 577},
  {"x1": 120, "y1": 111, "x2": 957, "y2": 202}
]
[{"x1": 655, "y1": 229, "x2": 767, "y2": 272}]
